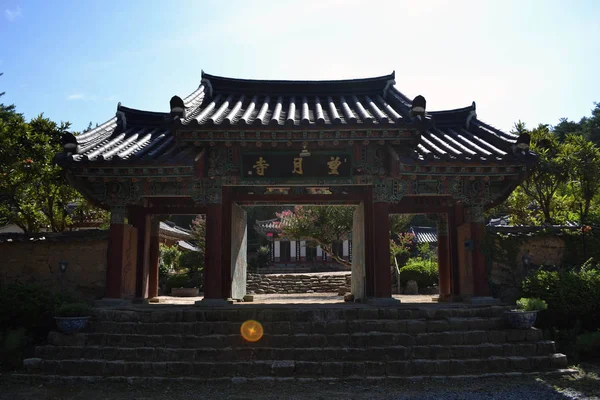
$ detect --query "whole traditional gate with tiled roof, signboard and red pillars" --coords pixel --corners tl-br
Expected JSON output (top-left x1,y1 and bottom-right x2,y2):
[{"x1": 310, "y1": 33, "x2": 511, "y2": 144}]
[{"x1": 56, "y1": 73, "x2": 536, "y2": 304}]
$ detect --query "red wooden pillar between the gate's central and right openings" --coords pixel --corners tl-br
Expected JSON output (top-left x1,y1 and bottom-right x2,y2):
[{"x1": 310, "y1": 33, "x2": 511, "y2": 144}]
[{"x1": 372, "y1": 202, "x2": 392, "y2": 298}]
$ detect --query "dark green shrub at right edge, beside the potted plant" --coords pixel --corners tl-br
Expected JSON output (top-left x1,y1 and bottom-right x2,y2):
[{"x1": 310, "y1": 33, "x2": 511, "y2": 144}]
[{"x1": 523, "y1": 270, "x2": 600, "y2": 330}]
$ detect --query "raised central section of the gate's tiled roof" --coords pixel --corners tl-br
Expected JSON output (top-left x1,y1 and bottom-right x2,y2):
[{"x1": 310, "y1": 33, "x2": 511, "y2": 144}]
[{"x1": 179, "y1": 74, "x2": 411, "y2": 127}]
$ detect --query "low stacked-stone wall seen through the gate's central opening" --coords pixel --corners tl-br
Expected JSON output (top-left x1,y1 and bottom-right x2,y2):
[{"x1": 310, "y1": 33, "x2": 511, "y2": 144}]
[{"x1": 248, "y1": 273, "x2": 351, "y2": 294}]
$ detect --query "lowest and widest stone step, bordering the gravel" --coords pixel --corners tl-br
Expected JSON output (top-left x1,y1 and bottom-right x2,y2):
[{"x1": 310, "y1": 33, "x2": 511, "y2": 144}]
[{"x1": 27, "y1": 354, "x2": 567, "y2": 379}]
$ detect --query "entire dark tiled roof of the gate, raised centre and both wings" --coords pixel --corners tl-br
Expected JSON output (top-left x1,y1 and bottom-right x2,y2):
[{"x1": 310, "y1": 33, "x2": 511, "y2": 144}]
[{"x1": 57, "y1": 73, "x2": 535, "y2": 165}]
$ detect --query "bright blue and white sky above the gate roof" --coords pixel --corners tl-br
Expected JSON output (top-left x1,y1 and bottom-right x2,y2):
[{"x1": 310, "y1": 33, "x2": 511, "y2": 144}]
[{"x1": 0, "y1": 0, "x2": 600, "y2": 130}]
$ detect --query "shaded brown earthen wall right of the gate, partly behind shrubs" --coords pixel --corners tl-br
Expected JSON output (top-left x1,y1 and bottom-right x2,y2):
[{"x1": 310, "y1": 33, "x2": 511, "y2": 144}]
[{"x1": 486, "y1": 235, "x2": 565, "y2": 302}]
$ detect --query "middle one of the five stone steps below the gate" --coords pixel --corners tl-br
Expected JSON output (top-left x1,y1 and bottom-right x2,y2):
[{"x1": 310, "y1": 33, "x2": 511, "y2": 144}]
[{"x1": 48, "y1": 329, "x2": 543, "y2": 348}]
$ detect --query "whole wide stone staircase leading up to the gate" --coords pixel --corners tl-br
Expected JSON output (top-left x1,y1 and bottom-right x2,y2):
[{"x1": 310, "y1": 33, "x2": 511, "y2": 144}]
[{"x1": 25, "y1": 305, "x2": 567, "y2": 382}]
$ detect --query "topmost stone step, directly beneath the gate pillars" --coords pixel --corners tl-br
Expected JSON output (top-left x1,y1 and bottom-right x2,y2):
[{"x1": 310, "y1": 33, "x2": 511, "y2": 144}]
[{"x1": 93, "y1": 305, "x2": 511, "y2": 323}]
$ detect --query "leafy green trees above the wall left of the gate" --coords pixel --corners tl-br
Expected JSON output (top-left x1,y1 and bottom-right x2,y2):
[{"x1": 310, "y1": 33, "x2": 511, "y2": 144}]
[{"x1": 0, "y1": 107, "x2": 106, "y2": 232}]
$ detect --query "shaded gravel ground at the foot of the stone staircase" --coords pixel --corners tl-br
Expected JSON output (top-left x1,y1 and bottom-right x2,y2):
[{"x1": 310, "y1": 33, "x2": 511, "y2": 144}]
[{"x1": 0, "y1": 365, "x2": 600, "y2": 400}]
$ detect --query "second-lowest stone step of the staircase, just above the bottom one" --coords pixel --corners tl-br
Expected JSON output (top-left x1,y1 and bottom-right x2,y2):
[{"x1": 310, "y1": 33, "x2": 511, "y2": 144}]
[{"x1": 35, "y1": 341, "x2": 556, "y2": 362}]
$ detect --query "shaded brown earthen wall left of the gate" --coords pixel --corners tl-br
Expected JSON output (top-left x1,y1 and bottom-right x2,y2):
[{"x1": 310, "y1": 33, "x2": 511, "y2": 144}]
[{"x1": 0, "y1": 231, "x2": 108, "y2": 299}]
